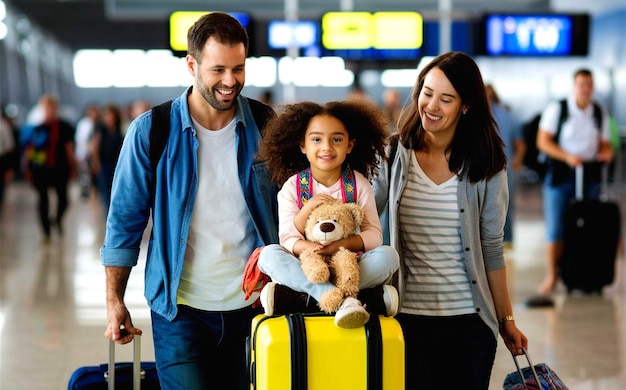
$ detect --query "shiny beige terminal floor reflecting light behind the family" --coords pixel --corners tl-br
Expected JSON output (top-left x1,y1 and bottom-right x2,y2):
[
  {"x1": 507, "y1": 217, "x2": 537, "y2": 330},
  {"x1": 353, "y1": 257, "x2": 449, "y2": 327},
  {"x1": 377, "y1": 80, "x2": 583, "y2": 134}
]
[{"x1": 0, "y1": 164, "x2": 626, "y2": 390}]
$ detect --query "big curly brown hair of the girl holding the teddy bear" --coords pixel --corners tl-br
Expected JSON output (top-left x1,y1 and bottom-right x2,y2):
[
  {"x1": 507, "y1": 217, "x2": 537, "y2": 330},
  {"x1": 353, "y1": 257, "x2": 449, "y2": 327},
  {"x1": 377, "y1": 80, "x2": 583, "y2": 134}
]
[{"x1": 257, "y1": 99, "x2": 388, "y2": 186}]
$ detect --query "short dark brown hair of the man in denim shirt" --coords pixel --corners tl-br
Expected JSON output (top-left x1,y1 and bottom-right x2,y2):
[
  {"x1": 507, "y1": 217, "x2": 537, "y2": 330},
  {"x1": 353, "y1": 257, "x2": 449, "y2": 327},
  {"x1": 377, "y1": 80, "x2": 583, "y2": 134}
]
[{"x1": 187, "y1": 12, "x2": 249, "y2": 61}]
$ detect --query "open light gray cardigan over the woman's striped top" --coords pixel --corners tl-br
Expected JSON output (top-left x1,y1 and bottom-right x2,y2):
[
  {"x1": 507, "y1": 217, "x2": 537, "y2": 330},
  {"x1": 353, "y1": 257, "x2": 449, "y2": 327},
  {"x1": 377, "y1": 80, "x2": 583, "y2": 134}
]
[{"x1": 372, "y1": 144, "x2": 509, "y2": 339}]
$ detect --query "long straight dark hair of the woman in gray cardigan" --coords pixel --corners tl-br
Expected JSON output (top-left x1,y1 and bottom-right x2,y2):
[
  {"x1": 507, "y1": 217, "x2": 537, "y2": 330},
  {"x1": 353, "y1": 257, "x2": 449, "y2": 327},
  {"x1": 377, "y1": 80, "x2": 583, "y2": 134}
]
[{"x1": 398, "y1": 52, "x2": 506, "y2": 183}]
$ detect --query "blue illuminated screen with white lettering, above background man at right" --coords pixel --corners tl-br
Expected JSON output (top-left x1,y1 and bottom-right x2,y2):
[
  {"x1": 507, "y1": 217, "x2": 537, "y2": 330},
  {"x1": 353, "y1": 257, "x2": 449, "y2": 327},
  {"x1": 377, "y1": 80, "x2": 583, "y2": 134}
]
[{"x1": 486, "y1": 15, "x2": 574, "y2": 56}]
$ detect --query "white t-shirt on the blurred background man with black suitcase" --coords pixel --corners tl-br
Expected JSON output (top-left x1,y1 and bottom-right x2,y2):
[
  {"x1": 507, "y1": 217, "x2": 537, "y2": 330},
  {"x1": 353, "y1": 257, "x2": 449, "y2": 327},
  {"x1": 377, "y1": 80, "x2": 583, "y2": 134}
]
[{"x1": 539, "y1": 97, "x2": 610, "y2": 161}]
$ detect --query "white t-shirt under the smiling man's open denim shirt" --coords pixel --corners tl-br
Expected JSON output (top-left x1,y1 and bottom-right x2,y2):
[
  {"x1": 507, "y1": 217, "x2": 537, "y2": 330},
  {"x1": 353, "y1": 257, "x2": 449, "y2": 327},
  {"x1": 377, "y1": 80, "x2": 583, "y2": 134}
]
[{"x1": 177, "y1": 119, "x2": 256, "y2": 311}]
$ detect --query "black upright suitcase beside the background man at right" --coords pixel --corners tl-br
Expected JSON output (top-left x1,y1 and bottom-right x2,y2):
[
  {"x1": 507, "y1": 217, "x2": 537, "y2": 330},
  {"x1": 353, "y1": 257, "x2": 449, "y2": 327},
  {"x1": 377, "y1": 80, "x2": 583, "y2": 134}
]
[{"x1": 560, "y1": 166, "x2": 621, "y2": 293}]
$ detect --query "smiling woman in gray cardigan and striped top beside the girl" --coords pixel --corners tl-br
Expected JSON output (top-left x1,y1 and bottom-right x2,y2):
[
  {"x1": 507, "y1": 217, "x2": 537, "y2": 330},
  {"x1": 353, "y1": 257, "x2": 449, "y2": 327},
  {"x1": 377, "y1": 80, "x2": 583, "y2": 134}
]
[{"x1": 373, "y1": 52, "x2": 528, "y2": 389}]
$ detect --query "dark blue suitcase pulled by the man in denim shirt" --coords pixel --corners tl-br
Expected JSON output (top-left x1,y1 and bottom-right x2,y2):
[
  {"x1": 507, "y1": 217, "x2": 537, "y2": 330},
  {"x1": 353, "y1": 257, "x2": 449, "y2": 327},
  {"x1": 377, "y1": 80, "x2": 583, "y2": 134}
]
[{"x1": 67, "y1": 335, "x2": 161, "y2": 390}]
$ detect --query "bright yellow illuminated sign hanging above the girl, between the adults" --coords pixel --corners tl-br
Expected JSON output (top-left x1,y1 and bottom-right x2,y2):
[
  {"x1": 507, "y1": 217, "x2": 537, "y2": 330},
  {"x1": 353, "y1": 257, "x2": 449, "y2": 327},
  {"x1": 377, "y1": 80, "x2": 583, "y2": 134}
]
[{"x1": 322, "y1": 12, "x2": 423, "y2": 50}]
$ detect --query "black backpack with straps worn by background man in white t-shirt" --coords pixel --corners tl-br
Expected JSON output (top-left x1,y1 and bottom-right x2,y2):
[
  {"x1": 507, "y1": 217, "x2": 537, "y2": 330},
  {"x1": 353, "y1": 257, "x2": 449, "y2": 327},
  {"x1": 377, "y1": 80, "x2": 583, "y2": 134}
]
[{"x1": 523, "y1": 99, "x2": 602, "y2": 179}]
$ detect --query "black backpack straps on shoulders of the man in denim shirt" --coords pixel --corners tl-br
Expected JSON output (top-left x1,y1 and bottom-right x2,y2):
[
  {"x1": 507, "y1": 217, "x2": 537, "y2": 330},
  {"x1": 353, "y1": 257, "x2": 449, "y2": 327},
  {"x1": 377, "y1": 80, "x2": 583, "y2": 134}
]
[{"x1": 150, "y1": 98, "x2": 275, "y2": 172}]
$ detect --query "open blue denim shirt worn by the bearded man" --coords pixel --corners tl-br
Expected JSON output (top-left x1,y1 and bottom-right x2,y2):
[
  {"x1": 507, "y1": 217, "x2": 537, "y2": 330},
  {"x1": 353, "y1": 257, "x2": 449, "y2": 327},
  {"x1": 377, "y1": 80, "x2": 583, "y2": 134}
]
[{"x1": 100, "y1": 87, "x2": 278, "y2": 320}]
